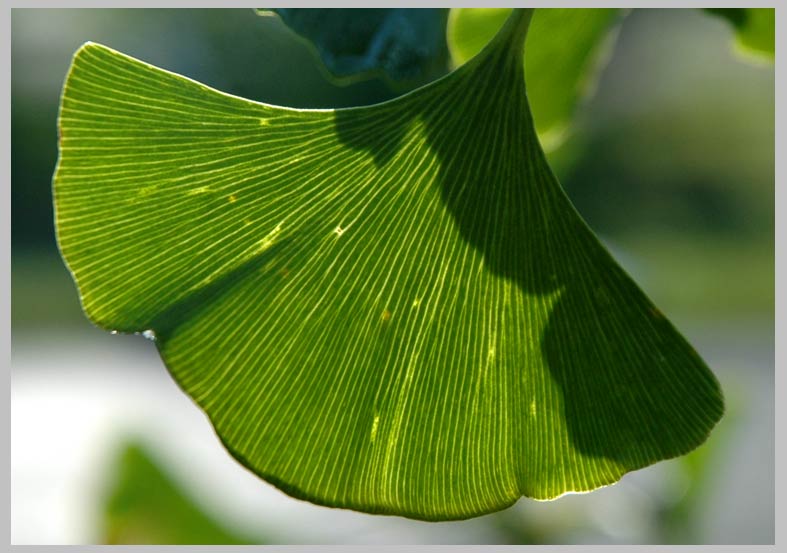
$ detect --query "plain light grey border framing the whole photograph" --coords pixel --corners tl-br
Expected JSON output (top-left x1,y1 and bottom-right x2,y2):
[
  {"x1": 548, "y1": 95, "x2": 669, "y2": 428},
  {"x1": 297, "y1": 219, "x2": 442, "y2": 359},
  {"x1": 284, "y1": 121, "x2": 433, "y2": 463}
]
[{"x1": 0, "y1": 0, "x2": 787, "y2": 552}]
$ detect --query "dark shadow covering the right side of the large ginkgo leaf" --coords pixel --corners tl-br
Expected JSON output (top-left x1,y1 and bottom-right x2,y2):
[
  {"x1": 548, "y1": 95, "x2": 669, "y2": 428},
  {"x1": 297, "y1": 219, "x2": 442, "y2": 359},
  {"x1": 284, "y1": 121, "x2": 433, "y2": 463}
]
[{"x1": 337, "y1": 11, "x2": 724, "y2": 474}]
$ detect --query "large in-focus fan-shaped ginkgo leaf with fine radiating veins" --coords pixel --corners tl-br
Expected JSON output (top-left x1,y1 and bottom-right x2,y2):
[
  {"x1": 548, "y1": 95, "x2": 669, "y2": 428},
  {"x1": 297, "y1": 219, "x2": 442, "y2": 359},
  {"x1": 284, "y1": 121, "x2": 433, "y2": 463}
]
[{"x1": 54, "y1": 10, "x2": 723, "y2": 520}]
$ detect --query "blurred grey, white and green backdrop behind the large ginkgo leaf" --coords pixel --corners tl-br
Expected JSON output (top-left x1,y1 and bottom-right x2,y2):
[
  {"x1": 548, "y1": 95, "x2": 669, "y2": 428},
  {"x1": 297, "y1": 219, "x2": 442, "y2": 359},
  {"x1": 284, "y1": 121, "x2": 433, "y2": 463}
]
[{"x1": 11, "y1": 9, "x2": 775, "y2": 543}]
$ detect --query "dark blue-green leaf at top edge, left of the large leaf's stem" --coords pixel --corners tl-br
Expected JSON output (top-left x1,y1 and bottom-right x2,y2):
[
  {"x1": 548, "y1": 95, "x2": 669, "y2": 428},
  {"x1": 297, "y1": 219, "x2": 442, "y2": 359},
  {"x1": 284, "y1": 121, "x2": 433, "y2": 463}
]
[{"x1": 258, "y1": 8, "x2": 448, "y2": 88}]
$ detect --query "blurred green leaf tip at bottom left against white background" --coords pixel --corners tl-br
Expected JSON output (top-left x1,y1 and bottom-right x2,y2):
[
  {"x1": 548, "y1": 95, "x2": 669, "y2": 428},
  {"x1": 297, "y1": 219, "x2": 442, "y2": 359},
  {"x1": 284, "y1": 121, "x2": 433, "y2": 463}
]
[{"x1": 101, "y1": 442, "x2": 262, "y2": 545}]
